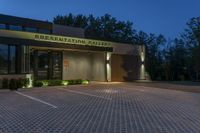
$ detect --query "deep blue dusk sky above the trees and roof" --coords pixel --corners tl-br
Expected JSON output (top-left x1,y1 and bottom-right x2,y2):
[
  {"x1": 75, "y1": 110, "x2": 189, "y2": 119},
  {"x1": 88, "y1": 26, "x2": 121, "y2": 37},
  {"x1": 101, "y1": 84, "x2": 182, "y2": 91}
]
[{"x1": 0, "y1": 0, "x2": 200, "y2": 38}]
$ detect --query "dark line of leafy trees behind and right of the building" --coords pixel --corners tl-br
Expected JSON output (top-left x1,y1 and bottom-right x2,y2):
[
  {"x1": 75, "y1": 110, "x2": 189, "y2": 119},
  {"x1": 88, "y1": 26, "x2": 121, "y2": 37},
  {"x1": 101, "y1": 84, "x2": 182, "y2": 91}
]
[{"x1": 54, "y1": 14, "x2": 200, "y2": 80}]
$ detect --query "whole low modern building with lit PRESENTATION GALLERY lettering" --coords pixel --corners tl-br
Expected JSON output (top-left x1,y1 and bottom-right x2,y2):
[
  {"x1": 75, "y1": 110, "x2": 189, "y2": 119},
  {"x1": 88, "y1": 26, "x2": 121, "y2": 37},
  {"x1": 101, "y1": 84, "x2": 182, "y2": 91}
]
[{"x1": 0, "y1": 14, "x2": 145, "y2": 85}]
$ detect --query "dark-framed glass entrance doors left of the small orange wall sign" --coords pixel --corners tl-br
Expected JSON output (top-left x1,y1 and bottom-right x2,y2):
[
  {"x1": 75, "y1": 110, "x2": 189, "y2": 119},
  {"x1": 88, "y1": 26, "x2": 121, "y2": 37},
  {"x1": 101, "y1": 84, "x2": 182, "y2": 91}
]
[{"x1": 30, "y1": 50, "x2": 62, "y2": 80}]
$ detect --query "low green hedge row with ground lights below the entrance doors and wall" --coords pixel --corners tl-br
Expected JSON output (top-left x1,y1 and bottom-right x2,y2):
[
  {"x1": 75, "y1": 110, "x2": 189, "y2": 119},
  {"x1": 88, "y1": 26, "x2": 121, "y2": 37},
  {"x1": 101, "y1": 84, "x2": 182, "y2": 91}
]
[{"x1": 33, "y1": 79, "x2": 89, "y2": 87}]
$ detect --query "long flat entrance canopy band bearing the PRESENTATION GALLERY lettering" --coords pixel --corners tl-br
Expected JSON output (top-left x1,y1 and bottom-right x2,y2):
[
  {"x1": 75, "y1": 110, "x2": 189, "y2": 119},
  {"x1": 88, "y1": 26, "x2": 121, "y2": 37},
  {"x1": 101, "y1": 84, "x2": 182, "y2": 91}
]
[{"x1": 0, "y1": 30, "x2": 113, "y2": 52}]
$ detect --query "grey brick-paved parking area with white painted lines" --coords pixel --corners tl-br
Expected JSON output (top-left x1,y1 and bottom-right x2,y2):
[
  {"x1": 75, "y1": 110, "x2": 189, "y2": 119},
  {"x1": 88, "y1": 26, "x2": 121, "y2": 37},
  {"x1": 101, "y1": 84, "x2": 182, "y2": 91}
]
[{"x1": 0, "y1": 83, "x2": 200, "y2": 133}]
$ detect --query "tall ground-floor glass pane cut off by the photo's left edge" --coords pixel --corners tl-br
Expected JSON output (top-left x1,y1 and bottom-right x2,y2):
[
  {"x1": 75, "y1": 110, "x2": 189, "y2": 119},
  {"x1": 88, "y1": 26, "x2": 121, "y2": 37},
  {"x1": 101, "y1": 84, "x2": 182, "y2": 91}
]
[{"x1": 0, "y1": 44, "x2": 8, "y2": 74}]
